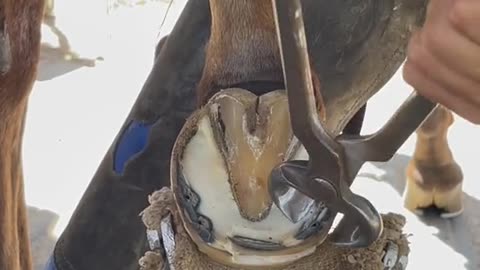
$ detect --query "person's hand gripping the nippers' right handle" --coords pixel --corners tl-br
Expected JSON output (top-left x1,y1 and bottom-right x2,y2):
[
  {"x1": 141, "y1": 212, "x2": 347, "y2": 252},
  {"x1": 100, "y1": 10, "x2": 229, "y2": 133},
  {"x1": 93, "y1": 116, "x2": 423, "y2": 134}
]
[{"x1": 403, "y1": 0, "x2": 480, "y2": 124}]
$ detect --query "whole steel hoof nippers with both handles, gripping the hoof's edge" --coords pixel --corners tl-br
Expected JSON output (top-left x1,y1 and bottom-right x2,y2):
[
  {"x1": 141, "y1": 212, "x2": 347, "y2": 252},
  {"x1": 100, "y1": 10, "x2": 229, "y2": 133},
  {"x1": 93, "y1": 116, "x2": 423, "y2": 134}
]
[{"x1": 270, "y1": 0, "x2": 435, "y2": 247}]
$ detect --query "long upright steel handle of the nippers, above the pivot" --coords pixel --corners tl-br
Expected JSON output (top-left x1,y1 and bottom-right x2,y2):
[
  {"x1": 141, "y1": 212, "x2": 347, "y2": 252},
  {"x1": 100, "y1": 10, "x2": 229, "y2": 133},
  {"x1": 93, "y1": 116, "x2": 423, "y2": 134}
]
[{"x1": 272, "y1": 0, "x2": 341, "y2": 162}]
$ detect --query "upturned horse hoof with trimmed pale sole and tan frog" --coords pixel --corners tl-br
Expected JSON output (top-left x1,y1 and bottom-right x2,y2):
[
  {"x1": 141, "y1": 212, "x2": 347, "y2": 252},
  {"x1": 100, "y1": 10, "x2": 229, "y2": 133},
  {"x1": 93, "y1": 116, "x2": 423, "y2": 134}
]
[{"x1": 170, "y1": 88, "x2": 335, "y2": 269}]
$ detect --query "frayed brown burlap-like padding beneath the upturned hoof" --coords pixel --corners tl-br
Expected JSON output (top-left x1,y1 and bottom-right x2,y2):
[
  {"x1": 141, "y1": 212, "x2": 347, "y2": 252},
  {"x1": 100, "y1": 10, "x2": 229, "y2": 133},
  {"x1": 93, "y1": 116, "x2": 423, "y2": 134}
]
[{"x1": 140, "y1": 189, "x2": 410, "y2": 270}]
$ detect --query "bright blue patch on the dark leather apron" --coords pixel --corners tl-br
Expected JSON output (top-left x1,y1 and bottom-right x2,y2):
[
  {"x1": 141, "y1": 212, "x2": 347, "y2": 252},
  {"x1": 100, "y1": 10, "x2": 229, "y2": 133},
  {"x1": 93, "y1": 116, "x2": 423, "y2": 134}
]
[{"x1": 113, "y1": 121, "x2": 151, "y2": 174}]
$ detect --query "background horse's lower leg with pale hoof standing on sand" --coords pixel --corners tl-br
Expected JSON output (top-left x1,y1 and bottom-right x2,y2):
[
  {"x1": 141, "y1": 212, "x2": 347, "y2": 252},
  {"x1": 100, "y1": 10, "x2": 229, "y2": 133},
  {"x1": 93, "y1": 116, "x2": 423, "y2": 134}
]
[{"x1": 404, "y1": 107, "x2": 463, "y2": 218}]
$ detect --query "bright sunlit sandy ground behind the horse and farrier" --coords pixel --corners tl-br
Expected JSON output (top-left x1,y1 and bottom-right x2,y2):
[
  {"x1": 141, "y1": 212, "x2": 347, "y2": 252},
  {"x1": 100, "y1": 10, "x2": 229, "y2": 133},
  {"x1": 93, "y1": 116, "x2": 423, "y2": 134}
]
[{"x1": 24, "y1": 0, "x2": 480, "y2": 270}]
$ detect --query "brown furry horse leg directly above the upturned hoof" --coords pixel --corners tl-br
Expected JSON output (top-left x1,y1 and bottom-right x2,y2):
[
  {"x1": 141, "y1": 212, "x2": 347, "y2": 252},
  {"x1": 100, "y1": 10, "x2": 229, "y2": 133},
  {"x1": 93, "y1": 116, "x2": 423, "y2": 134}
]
[{"x1": 197, "y1": 0, "x2": 325, "y2": 119}]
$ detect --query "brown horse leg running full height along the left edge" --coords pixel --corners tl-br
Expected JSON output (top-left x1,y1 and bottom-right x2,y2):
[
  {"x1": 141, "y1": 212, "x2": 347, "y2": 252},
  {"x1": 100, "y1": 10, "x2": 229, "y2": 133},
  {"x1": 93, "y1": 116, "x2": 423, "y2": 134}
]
[{"x1": 0, "y1": 0, "x2": 43, "y2": 270}]
